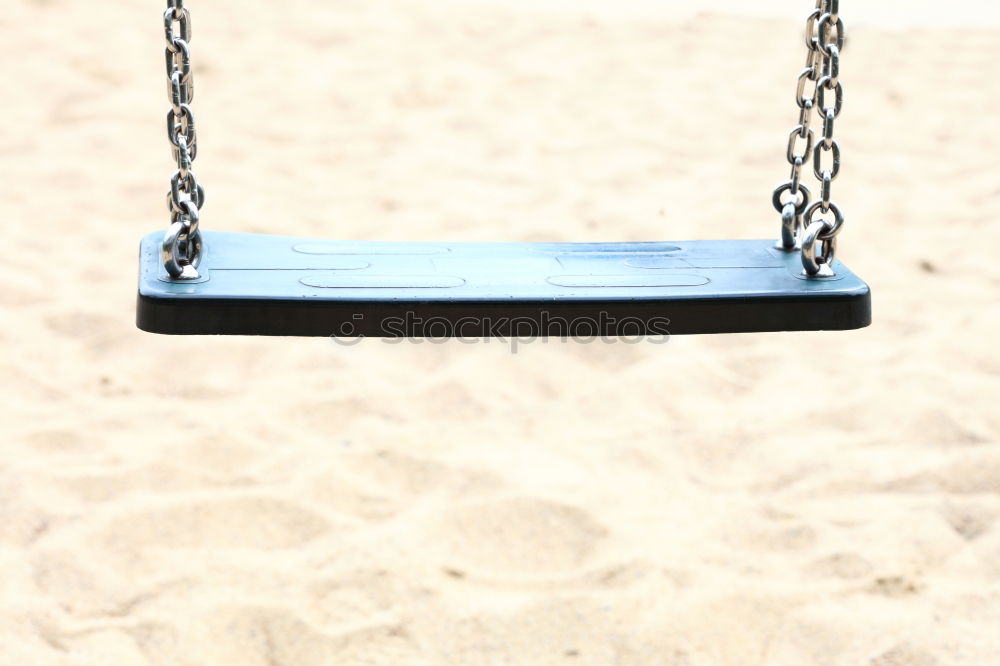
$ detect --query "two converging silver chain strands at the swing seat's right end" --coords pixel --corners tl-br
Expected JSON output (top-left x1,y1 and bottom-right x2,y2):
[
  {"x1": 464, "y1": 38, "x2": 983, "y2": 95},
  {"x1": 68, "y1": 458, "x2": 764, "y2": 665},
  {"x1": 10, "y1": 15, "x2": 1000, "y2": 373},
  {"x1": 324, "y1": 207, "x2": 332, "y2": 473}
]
[{"x1": 772, "y1": 0, "x2": 845, "y2": 277}]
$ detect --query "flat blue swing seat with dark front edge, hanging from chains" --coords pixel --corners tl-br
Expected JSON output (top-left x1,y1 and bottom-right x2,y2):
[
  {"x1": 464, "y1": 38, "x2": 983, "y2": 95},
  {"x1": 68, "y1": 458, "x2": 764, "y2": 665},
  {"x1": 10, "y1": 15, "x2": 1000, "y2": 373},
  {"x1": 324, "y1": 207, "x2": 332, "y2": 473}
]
[{"x1": 136, "y1": 231, "x2": 871, "y2": 338}]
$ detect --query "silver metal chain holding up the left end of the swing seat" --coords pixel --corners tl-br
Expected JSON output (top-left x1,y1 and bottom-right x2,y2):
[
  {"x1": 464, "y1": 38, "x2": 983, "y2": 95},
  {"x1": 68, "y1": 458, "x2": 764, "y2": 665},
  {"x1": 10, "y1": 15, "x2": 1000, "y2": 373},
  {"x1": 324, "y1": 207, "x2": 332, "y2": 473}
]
[{"x1": 162, "y1": 0, "x2": 205, "y2": 280}]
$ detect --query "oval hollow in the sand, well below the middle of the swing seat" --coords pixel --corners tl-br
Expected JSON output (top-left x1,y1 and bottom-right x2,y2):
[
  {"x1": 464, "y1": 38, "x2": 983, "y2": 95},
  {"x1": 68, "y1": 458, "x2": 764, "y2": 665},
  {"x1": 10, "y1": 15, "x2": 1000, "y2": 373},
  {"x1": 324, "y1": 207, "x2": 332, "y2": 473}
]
[{"x1": 438, "y1": 497, "x2": 608, "y2": 575}]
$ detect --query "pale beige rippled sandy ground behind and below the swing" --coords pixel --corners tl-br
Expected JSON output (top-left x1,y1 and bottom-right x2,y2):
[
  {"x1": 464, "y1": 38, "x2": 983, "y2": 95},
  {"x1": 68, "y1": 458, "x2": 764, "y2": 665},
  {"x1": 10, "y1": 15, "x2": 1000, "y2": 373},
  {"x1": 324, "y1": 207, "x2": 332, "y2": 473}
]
[{"x1": 0, "y1": 0, "x2": 1000, "y2": 666}]
